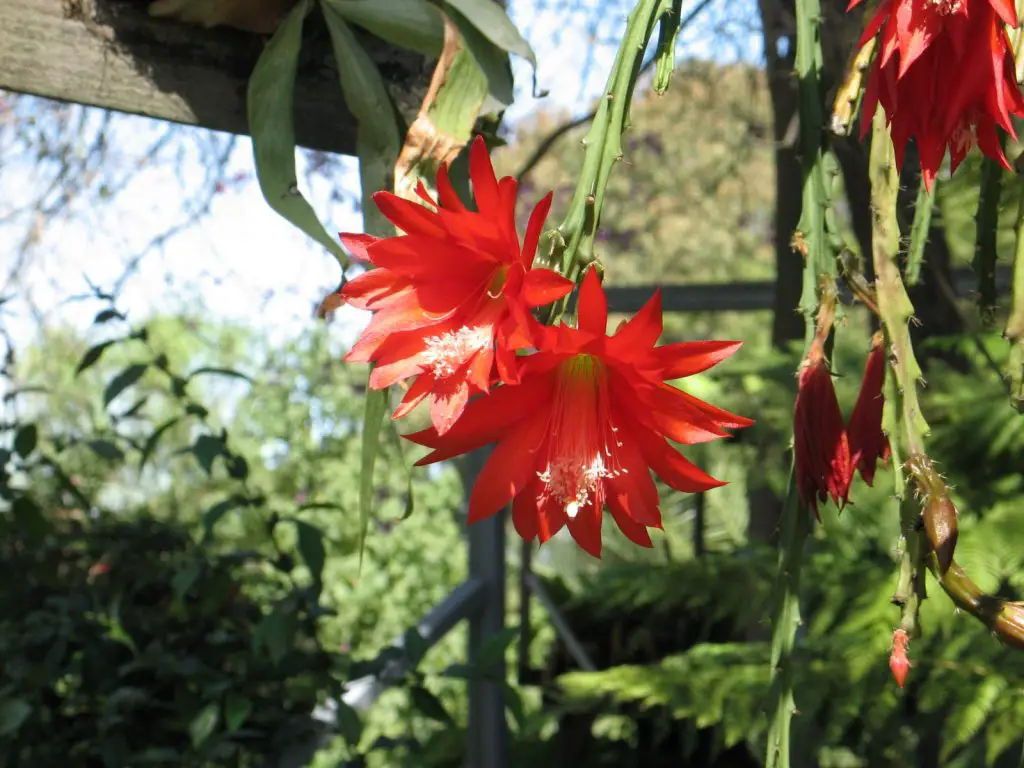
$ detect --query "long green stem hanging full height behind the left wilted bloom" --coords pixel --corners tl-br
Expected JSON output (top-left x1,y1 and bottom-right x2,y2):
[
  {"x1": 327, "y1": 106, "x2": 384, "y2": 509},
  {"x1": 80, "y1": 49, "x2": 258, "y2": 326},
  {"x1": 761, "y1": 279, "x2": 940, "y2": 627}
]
[{"x1": 765, "y1": 0, "x2": 837, "y2": 768}]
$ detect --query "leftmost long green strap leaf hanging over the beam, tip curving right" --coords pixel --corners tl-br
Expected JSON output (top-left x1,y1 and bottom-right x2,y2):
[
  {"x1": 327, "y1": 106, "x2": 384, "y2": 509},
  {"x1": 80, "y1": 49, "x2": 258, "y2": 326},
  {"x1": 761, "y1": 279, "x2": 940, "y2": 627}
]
[{"x1": 247, "y1": 0, "x2": 347, "y2": 264}]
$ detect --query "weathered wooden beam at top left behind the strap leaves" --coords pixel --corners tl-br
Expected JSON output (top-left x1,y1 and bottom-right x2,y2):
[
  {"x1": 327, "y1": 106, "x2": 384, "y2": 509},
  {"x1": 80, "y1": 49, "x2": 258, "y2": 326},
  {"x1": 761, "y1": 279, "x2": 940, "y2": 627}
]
[{"x1": 0, "y1": 0, "x2": 430, "y2": 155}]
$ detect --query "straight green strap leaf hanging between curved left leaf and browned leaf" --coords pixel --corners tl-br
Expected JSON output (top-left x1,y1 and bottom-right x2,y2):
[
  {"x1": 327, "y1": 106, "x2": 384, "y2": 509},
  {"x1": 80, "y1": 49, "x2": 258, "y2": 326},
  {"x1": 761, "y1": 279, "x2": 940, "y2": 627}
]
[{"x1": 324, "y1": 0, "x2": 402, "y2": 238}]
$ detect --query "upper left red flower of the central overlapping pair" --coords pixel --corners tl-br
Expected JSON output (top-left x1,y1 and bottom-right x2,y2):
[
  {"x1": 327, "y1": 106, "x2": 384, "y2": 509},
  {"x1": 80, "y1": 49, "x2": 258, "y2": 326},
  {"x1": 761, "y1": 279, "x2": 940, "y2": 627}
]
[{"x1": 341, "y1": 138, "x2": 572, "y2": 434}]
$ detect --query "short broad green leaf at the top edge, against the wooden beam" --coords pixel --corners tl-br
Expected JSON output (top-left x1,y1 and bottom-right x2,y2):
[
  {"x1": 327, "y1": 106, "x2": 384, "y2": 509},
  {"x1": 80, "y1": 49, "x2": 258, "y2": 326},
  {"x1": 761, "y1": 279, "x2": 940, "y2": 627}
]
[{"x1": 327, "y1": 0, "x2": 444, "y2": 58}]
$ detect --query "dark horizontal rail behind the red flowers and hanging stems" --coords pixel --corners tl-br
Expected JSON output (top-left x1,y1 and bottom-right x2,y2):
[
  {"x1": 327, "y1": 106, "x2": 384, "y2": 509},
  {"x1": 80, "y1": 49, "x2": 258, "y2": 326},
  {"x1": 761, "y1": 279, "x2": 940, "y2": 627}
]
[{"x1": 605, "y1": 267, "x2": 1011, "y2": 312}]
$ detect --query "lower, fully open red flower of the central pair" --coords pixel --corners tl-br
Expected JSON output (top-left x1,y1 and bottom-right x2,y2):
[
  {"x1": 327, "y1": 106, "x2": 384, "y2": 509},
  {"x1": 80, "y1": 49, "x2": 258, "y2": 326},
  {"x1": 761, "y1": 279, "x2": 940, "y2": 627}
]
[{"x1": 409, "y1": 270, "x2": 753, "y2": 557}]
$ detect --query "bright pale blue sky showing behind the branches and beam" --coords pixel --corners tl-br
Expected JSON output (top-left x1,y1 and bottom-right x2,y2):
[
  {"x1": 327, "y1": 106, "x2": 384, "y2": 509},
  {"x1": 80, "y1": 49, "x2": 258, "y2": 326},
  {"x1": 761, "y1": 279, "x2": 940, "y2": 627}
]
[{"x1": 0, "y1": 0, "x2": 761, "y2": 366}]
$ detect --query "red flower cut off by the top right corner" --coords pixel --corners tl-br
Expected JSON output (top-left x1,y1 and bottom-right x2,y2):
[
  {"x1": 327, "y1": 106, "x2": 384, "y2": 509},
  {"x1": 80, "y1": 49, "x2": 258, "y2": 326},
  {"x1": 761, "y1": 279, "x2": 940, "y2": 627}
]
[{"x1": 849, "y1": 0, "x2": 1024, "y2": 188}]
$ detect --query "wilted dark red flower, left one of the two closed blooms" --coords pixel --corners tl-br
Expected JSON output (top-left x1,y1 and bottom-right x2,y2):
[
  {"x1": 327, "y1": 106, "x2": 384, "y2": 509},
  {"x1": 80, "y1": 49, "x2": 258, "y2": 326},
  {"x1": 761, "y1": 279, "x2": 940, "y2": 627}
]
[{"x1": 793, "y1": 340, "x2": 853, "y2": 516}]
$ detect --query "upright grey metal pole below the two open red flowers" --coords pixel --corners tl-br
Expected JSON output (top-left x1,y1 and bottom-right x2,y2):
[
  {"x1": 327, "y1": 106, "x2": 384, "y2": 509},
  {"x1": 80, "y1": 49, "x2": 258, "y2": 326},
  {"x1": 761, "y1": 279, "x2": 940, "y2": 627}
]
[{"x1": 463, "y1": 450, "x2": 509, "y2": 768}]
